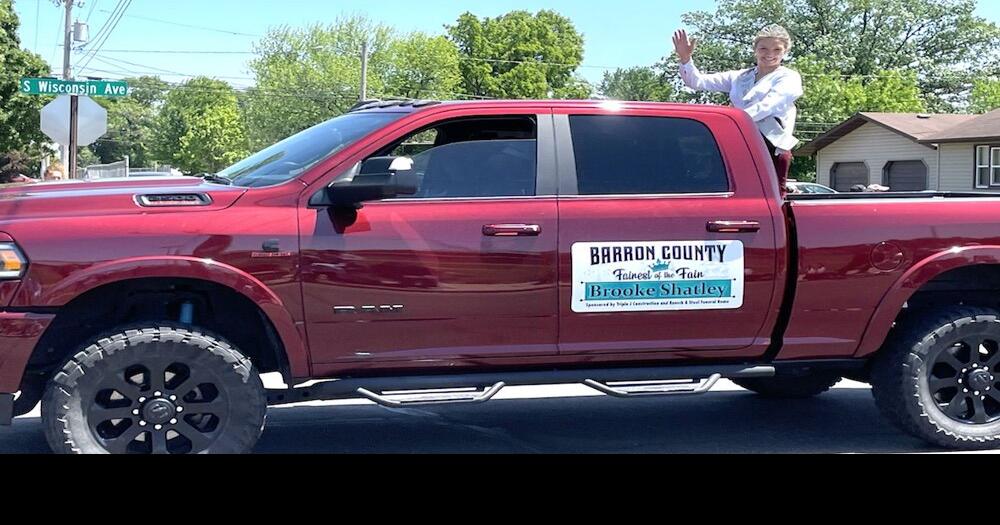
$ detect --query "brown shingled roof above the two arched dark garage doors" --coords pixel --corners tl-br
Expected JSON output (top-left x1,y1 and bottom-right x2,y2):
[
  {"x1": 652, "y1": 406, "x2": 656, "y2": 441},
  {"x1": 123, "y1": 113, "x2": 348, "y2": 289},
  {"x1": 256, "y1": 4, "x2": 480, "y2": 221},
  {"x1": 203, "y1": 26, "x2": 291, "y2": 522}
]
[{"x1": 795, "y1": 111, "x2": 984, "y2": 157}]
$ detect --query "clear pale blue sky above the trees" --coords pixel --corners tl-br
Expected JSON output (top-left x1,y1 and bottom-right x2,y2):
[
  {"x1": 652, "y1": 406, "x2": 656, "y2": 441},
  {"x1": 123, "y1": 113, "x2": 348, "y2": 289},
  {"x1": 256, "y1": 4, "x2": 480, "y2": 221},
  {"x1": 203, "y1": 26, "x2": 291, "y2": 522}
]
[{"x1": 14, "y1": 0, "x2": 1000, "y2": 86}]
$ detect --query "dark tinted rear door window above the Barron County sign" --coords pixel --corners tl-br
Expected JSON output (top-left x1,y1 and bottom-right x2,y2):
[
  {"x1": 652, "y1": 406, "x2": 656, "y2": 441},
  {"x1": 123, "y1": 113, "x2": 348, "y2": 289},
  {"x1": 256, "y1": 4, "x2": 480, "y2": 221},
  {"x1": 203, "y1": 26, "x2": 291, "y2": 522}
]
[{"x1": 569, "y1": 115, "x2": 730, "y2": 195}]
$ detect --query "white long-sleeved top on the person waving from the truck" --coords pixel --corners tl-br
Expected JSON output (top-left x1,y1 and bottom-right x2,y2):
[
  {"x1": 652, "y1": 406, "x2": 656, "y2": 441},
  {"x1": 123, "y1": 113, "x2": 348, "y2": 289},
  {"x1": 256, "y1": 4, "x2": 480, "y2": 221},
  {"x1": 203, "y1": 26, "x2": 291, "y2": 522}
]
[{"x1": 681, "y1": 60, "x2": 802, "y2": 153}]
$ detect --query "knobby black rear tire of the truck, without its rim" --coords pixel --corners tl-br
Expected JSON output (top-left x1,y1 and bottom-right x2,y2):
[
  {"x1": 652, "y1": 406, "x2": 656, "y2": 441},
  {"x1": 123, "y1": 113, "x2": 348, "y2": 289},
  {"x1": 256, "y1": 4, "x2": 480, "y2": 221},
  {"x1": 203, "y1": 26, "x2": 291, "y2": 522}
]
[{"x1": 872, "y1": 307, "x2": 1000, "y2": 450}]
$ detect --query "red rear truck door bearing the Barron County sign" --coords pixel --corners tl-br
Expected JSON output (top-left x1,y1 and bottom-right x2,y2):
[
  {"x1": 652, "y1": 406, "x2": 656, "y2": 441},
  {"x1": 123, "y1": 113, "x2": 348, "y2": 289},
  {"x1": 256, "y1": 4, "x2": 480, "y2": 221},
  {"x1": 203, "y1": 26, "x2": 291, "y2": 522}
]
[{"x1": 555, "y1": 110, "x2": 783, "y2": 357}]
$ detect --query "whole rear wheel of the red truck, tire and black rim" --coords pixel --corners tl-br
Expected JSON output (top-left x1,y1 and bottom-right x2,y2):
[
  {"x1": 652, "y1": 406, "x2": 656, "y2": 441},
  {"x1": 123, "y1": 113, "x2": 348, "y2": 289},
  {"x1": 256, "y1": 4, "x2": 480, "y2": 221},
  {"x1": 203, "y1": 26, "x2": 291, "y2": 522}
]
[{"x1": 872, "y1": 307, "x2": 1000, "y2": 449}]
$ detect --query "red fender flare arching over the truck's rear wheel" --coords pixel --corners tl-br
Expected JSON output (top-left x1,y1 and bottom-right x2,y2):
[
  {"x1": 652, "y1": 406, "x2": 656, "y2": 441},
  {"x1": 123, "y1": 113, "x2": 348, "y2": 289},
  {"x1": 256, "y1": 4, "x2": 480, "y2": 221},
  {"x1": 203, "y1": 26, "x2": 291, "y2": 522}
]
[{"x1": 855, "y1": 246, "x2": 1000, "y2": 358}]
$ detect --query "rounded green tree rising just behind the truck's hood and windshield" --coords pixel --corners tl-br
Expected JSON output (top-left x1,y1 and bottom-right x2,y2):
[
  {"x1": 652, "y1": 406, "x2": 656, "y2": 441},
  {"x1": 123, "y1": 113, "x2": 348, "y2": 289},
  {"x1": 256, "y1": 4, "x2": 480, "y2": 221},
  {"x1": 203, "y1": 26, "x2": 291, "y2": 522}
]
[{"x1": 153, "y1": 77, "x2": 248, "y2": 173}]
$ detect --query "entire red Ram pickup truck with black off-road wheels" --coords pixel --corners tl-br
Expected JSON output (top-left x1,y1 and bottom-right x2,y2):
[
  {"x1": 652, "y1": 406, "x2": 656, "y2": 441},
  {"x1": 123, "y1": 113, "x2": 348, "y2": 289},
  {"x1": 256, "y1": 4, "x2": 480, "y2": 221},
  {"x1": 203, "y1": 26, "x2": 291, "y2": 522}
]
[{"x1": 0, "y1": 101, "x2": 1000, "y2": 453}]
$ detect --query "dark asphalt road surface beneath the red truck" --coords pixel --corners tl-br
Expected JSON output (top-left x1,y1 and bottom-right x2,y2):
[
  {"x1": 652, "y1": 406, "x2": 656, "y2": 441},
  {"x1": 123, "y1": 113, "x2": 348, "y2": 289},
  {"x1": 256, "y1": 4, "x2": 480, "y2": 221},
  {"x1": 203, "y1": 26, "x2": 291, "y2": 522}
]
[{"x1": 0, "y1": 381, "x2": 992, "y2": 454}]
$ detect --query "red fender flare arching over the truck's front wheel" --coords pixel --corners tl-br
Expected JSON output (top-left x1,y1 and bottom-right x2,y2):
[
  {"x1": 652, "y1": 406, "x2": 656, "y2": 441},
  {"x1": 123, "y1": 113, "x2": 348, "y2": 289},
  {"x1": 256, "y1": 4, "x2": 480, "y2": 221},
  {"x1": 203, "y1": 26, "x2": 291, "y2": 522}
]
[{"x1": 28, "y1": 256, "x2": 309, "y2": 378}]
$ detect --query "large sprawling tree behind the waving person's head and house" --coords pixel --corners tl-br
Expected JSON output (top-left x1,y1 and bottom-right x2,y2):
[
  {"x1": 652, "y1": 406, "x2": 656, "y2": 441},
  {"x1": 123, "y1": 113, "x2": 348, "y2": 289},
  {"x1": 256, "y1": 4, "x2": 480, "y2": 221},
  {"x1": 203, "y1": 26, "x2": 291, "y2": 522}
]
[{"x1": 661, "y1": 0, "x2": 1000, "y2": 111}]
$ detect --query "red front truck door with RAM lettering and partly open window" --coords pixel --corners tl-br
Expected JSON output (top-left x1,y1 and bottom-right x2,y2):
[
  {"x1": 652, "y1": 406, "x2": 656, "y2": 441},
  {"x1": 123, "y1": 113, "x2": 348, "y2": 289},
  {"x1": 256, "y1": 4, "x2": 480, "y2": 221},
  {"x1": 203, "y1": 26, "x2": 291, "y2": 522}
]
[{"x1": 302, "y1": 113, "x2": 558, "y2": 368}]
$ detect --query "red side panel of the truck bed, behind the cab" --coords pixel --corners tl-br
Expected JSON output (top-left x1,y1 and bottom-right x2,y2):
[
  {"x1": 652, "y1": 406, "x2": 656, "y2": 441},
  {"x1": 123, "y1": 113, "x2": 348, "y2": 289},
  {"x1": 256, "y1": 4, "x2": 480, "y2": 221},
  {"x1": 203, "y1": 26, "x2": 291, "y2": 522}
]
[{"x1": 778, "y1": 196, "x2": 1000, "y2": 359}]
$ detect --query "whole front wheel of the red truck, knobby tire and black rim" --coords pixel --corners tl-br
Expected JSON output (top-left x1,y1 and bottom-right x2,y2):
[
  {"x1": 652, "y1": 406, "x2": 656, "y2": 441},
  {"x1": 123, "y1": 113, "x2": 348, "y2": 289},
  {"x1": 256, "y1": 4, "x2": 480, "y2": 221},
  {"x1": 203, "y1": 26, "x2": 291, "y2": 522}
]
[{"x1": 42, "y1": 323, "x2": 267, "y2": 454}]
